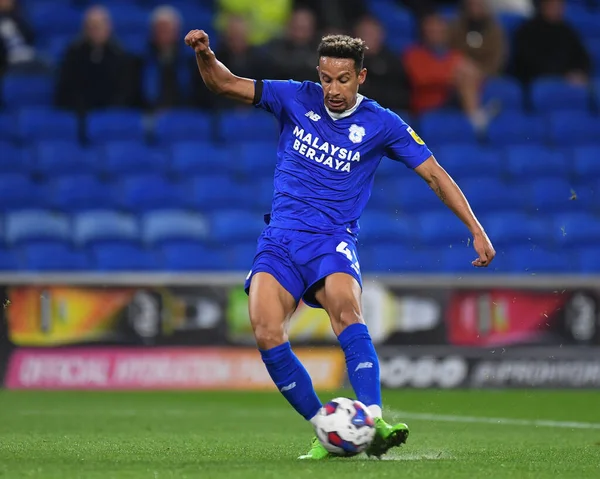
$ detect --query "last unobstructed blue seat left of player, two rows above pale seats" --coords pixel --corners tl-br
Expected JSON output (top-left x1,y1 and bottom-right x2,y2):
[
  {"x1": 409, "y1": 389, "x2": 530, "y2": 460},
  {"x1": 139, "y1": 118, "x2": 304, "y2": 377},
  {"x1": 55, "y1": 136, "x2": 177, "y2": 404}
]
[{"x1": 171, "y1": 141, "x2": 237, "y2": 176}]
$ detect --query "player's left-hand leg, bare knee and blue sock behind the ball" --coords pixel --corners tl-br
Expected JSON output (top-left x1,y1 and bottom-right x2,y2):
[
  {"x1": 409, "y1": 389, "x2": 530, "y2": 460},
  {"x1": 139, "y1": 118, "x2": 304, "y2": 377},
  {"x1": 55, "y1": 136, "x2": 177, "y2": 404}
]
[{"x1": 248, "y1": 270, "x2": 328, "y2": 458}]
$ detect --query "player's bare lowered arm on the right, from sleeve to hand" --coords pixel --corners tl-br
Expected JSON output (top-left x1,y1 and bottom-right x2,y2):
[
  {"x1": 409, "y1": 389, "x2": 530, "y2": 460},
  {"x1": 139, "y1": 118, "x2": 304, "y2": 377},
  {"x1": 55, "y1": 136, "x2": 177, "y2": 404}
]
[{"x1": 415, "y1": 156, "x2": 496, "y2": 267}]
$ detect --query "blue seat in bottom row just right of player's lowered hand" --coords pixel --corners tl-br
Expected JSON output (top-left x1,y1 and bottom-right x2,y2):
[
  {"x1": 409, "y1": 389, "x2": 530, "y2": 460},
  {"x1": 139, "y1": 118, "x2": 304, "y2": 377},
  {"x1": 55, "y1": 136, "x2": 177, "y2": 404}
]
[{"x1": 506, "y1": 245, "x2": 578, "y2": 274}]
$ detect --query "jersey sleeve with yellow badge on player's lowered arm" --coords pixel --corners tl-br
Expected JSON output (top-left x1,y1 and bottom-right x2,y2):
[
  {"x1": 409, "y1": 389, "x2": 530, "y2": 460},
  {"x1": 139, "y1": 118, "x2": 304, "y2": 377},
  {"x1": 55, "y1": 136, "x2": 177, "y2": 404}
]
[{"x1": 385, "y1": 110, "x2": 432, "y2": 169}]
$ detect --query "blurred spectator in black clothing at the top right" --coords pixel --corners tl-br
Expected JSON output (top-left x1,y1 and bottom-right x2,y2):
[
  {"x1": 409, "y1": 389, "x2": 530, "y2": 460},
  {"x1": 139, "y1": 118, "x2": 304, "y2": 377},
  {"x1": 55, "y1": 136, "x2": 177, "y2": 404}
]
[{"x1": 514, "y1": 0, "x2": 591, "y2": 84}]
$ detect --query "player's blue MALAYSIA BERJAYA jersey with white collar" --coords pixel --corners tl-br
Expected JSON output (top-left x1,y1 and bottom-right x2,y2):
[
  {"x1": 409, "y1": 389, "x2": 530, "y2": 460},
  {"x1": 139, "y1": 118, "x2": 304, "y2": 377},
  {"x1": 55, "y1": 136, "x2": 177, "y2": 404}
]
[{"x1": 256, "y1": 80, "x2": 431, "y2": 234}]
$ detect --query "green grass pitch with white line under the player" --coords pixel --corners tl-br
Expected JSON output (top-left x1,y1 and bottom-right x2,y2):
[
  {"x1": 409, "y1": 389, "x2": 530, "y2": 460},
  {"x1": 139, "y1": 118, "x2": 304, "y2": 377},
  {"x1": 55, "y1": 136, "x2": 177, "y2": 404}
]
[{"x1": 0, "y1": 390, "x2": 600, "y2": 479}]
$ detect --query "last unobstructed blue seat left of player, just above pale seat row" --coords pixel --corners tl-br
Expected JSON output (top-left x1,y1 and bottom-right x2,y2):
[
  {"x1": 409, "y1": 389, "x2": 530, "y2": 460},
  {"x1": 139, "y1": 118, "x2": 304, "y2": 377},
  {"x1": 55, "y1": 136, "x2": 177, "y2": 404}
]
[{"x1": 186, "y1": 175, "x2": 252, "y2": 210}]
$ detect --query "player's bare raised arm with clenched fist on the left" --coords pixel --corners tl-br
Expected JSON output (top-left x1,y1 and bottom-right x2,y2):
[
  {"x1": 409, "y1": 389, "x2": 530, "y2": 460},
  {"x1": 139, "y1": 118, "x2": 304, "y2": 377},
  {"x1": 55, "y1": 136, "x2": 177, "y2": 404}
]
[{"x1": 185, "y1": 30, "x2": 254, "y2": 103}]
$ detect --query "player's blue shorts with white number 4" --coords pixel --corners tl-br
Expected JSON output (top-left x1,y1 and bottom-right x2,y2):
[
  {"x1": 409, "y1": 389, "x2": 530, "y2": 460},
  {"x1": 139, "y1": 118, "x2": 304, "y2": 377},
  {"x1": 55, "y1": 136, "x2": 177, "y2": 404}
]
[{"x1": 245, "y1": 226, "x2": 362, "y2": 308}]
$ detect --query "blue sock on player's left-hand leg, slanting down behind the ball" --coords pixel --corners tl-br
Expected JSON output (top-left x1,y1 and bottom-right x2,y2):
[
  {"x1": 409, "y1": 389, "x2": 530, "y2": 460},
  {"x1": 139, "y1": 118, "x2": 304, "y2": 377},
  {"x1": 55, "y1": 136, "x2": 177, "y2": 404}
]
[{"x1": 260, "y1": 342, "x2": 321, "y2": 421}]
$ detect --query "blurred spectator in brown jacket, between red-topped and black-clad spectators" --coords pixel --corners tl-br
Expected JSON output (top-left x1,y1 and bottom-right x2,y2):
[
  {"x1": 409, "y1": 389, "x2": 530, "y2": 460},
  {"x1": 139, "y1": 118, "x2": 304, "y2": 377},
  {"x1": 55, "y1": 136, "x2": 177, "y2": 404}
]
[{"x1": 450, "y1": 0, "x2": 506, "y2": 77}]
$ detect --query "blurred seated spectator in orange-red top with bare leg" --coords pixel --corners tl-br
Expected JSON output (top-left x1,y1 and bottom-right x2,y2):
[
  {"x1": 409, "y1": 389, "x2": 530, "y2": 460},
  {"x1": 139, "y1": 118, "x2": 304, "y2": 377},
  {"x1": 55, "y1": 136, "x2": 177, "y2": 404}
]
[{"x1": 404, "y1": 14, "x2": 489, "y2": 131}]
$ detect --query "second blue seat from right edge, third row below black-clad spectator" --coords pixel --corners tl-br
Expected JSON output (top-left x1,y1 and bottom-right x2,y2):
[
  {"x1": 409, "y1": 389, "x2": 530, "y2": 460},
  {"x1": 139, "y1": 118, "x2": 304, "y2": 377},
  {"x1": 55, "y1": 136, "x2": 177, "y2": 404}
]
[{"x1": 506, "y1": 146, "x2": 569, "y2": 178}]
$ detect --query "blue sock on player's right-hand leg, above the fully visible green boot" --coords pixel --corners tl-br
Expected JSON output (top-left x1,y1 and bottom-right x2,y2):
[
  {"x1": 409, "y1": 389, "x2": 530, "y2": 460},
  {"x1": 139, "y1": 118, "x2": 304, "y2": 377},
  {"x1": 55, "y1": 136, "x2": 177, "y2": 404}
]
[{"x1": 338, "y1": 323, "x2": 381, "y2": 408}]
